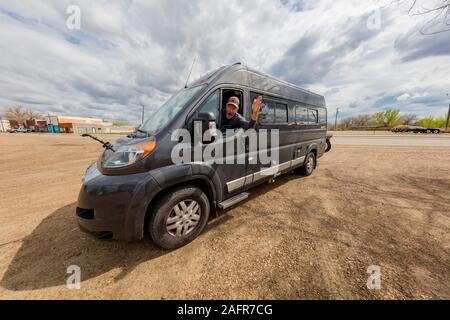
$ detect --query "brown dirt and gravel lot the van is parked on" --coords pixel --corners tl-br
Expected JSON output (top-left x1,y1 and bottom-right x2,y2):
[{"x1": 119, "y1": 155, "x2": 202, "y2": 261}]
[{"x1": 0, "y1": 134, "x2": 450, "y2": 299}]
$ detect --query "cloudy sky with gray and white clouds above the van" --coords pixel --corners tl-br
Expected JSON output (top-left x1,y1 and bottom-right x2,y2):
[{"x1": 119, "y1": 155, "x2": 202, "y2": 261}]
[{"x1": 0, "y1": 0, "x2": 450, "y2": 124}]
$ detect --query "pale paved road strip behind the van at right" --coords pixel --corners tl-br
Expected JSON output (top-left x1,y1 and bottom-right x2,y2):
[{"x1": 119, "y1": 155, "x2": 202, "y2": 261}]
[{"x1": 332, "y1": 134, "x2": 450, "y2": 147}]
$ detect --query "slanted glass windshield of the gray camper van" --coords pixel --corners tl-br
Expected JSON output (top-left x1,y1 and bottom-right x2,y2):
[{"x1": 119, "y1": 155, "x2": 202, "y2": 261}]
[{"x1": 139, "y1": 85, "x2": 205, "y2": 134}]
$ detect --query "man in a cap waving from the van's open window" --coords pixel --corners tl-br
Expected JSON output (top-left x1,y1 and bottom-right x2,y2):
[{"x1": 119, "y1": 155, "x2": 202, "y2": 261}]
[{"x1": 220, "y1": 96, "x2": 262, "y2": 131}]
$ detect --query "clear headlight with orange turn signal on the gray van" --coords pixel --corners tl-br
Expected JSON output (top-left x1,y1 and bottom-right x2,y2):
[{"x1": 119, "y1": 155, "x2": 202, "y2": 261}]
[{"x1": 102, "y1": 140, "x2": 156, "y2": 169}]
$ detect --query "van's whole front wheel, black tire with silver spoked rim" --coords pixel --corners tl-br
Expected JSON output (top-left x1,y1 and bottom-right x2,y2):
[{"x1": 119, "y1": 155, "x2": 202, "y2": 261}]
[{"x1": 148, "y1": 186, "x2": 210, "y2": 250}]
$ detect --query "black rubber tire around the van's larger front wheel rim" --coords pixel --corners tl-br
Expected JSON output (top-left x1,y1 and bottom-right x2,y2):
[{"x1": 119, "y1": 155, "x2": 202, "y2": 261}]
[{"x1": 147, "y1": 186, "x2": 210, "y2": 250}]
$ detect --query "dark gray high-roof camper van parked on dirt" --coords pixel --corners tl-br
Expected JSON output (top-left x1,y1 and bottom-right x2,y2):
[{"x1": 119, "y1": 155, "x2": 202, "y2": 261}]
[{"x1": 76, "y1": 63, "x2": 327, "y2": 249}]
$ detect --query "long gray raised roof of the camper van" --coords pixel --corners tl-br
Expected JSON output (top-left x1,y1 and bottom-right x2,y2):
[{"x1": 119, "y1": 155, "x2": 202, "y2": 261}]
[{"x1": 189, "y1": 62, "x2": 325, "y2": 107}]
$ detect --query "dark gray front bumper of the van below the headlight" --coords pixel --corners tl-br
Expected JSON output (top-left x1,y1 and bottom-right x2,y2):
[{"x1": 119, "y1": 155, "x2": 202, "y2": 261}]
[{"x1": 76, "y1": 164, "x2": 160, "y2": 241}]
